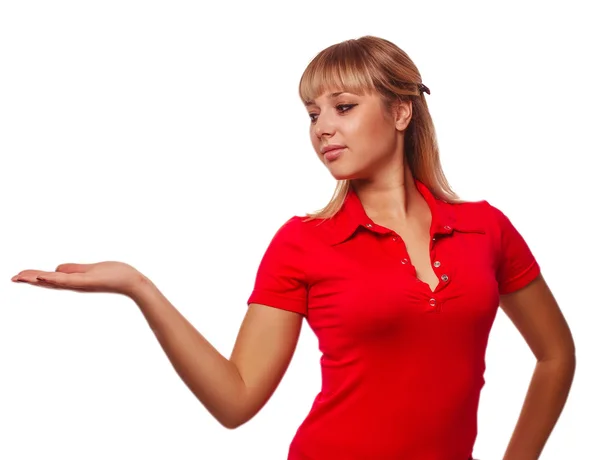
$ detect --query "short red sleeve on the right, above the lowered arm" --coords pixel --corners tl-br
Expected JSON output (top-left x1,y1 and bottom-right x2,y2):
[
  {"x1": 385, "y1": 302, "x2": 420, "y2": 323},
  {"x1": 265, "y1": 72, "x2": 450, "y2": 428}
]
[{"x1": 490, "y1": 205, "x2": 540, "y2": 295}]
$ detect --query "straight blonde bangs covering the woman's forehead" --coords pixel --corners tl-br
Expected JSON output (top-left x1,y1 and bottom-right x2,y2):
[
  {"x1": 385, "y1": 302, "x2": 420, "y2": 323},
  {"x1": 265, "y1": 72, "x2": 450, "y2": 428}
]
[{"x1": 299, "y1": 41, "x2": 375, "y2": 104}]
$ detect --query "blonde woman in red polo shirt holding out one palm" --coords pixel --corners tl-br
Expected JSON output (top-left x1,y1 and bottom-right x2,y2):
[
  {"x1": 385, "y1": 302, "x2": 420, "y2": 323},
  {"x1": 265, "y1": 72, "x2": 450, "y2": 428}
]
[{"x1": 13, "y1": 36, "x2": 575, "y2": 460}]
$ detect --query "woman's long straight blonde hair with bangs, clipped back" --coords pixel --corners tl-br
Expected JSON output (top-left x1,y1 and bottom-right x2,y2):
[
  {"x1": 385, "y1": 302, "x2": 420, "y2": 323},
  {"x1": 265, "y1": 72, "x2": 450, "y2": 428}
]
[{"x1": 299, "y1": 36, "x2": 462, "y2": 220}]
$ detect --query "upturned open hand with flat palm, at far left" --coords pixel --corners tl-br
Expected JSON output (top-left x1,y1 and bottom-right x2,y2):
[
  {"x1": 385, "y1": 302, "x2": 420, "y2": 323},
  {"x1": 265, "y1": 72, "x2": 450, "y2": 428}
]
[{"x1": 12, "y1": 262, "x2": 146, "y2": 297}]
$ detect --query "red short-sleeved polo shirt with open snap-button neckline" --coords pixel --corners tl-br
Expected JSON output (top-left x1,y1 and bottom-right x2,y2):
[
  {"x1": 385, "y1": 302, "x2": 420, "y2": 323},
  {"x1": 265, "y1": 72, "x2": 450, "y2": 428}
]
[{"x1": 248, "y1": 181, "x2": 540, "y2": 460}]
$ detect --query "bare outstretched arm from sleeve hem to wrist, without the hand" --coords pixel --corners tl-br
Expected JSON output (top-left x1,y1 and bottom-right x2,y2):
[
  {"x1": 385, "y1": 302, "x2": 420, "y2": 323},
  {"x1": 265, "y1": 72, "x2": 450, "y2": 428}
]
[{"x1": 131, "y1": 277, "x2": 303, "y2": 429}]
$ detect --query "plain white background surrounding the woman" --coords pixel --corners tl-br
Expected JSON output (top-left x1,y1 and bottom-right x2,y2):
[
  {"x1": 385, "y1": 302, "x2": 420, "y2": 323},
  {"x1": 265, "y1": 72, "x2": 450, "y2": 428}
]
[{"x1": 0, "y1": 0, "x2": 600, "y2": 460}]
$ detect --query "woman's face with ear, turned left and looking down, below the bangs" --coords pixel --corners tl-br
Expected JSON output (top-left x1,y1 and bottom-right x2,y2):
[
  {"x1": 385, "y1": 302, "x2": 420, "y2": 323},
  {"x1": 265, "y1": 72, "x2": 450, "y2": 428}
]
[{"x1": 306, "y1": 91, "x2": 412, "y2": 180}]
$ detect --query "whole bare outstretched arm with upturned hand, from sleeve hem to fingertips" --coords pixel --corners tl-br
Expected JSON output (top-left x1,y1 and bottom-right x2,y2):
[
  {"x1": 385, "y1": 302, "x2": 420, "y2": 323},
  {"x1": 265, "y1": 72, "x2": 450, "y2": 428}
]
[{"x1": 12, "y1": 262, "x2": 303, "y2": 428}]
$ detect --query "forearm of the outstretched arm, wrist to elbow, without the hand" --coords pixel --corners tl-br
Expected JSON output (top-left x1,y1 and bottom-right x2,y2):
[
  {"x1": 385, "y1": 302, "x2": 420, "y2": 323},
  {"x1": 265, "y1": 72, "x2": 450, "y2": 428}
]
[{"x1": 131, "y1": 278, "x2": 245, "y2": 428}]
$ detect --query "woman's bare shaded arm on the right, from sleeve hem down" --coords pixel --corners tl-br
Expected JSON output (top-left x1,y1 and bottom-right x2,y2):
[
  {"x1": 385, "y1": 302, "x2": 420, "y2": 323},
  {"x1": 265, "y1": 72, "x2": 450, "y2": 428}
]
[{"x1": 500, "y1": 275, "x2": 575, "y2": 460}]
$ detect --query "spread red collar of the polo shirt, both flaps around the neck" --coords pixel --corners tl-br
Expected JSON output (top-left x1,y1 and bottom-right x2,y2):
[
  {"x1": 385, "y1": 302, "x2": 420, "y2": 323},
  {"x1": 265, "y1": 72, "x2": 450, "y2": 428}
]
[{"x1": 324, "y1": 179, "x2": 485, "y2": 245}]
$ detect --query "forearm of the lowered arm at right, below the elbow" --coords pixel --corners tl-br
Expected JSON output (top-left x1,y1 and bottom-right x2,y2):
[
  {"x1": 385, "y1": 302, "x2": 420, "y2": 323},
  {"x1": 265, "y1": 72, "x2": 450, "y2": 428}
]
[{"x1": 503, "y1": 355, "x2": 575, "y2": 460}]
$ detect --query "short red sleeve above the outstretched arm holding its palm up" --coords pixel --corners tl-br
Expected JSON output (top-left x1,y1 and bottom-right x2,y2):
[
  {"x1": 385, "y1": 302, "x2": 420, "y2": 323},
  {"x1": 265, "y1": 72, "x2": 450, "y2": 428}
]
[{"x1": 247, "y1": 217, "x2": 308, "y2": 316}]
